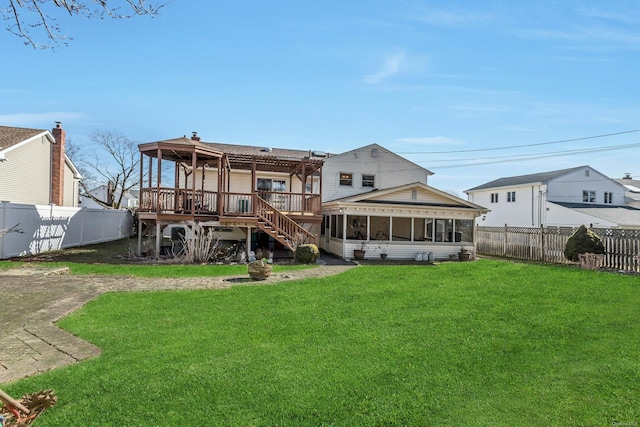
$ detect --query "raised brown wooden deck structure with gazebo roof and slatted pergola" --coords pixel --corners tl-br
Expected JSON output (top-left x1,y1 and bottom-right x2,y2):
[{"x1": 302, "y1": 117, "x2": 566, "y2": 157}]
[{"x1": 138, "y1": 137, "x2": 323, "y2": 253}]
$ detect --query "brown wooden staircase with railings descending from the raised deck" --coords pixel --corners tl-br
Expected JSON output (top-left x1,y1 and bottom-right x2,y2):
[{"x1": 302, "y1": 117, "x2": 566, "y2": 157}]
[{"x1": 256, "y1": 197, "x2": 316, "y2": 250}]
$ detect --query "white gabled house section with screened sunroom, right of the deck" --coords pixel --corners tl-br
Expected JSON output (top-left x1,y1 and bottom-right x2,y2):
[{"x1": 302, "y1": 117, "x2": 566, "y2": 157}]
[{"x1": 319, "y1": 144, "x2": 488, "y2": 259}]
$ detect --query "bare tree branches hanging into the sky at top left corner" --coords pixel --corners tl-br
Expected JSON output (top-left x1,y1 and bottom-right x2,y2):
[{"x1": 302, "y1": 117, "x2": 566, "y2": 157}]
[{"x1": 0, "y1": 0, "x2": 165, "y2": 48}]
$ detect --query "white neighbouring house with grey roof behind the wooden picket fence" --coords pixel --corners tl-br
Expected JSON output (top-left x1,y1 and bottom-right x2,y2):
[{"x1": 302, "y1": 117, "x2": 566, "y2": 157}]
[{"x1": 465, "y1": 166, "x2": 640, "y2": 228}]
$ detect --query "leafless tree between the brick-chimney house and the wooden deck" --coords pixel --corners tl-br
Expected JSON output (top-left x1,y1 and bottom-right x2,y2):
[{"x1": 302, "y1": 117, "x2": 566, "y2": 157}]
[{"x1": 78, "y1": 130, "x2": 140, "y2": 209}]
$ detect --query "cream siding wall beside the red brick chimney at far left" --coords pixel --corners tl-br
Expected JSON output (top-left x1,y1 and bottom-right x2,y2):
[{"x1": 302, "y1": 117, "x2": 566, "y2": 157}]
[{"x1": 0, "y1": 136, "x2": 51, "y2": 205}]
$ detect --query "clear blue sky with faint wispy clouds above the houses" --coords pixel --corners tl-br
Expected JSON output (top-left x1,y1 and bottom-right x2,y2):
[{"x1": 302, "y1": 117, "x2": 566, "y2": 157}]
[{"x1": 0, "y1": 0, "x2": 640, "y2": 197}]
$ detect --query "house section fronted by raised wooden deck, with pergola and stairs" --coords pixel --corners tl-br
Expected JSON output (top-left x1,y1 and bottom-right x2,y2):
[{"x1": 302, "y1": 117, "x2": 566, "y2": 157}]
[{"x1": 138, "y1": 133, "x2": 324, "y2": 254}]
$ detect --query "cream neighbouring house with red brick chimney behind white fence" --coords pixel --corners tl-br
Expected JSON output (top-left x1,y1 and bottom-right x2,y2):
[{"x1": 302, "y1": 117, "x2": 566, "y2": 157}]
[{"x1": 0, "y1": 123, "x2": 82, "y2": 207}]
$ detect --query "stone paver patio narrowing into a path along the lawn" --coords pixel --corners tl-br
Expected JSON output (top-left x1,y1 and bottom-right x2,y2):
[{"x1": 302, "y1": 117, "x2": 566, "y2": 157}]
[{"x1": 0, "y1": 263, "x2": 355, "y2": 384}]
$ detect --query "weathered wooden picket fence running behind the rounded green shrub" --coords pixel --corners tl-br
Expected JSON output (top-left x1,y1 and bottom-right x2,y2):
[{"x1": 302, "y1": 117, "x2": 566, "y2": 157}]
[{"x1": 476, "y1": 227, "x2": 640, "y2": 273}]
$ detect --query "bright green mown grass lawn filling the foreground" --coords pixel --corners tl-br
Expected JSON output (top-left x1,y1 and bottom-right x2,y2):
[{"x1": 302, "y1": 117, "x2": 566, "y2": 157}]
[{"x1": 4, "y1": 260, "x2": 640, "y2": 427}]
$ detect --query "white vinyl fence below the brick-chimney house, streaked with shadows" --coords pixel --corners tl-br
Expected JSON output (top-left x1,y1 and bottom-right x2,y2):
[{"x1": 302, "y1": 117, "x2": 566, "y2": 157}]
[{"x1": 0, "y1": 202, "x2": 133, "y2": 259}]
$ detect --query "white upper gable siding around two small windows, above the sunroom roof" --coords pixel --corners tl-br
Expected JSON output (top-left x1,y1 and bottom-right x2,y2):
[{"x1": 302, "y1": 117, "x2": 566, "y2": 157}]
[{"x1": 322, "y1": 145, "x2": 429, "y2": 202}]
